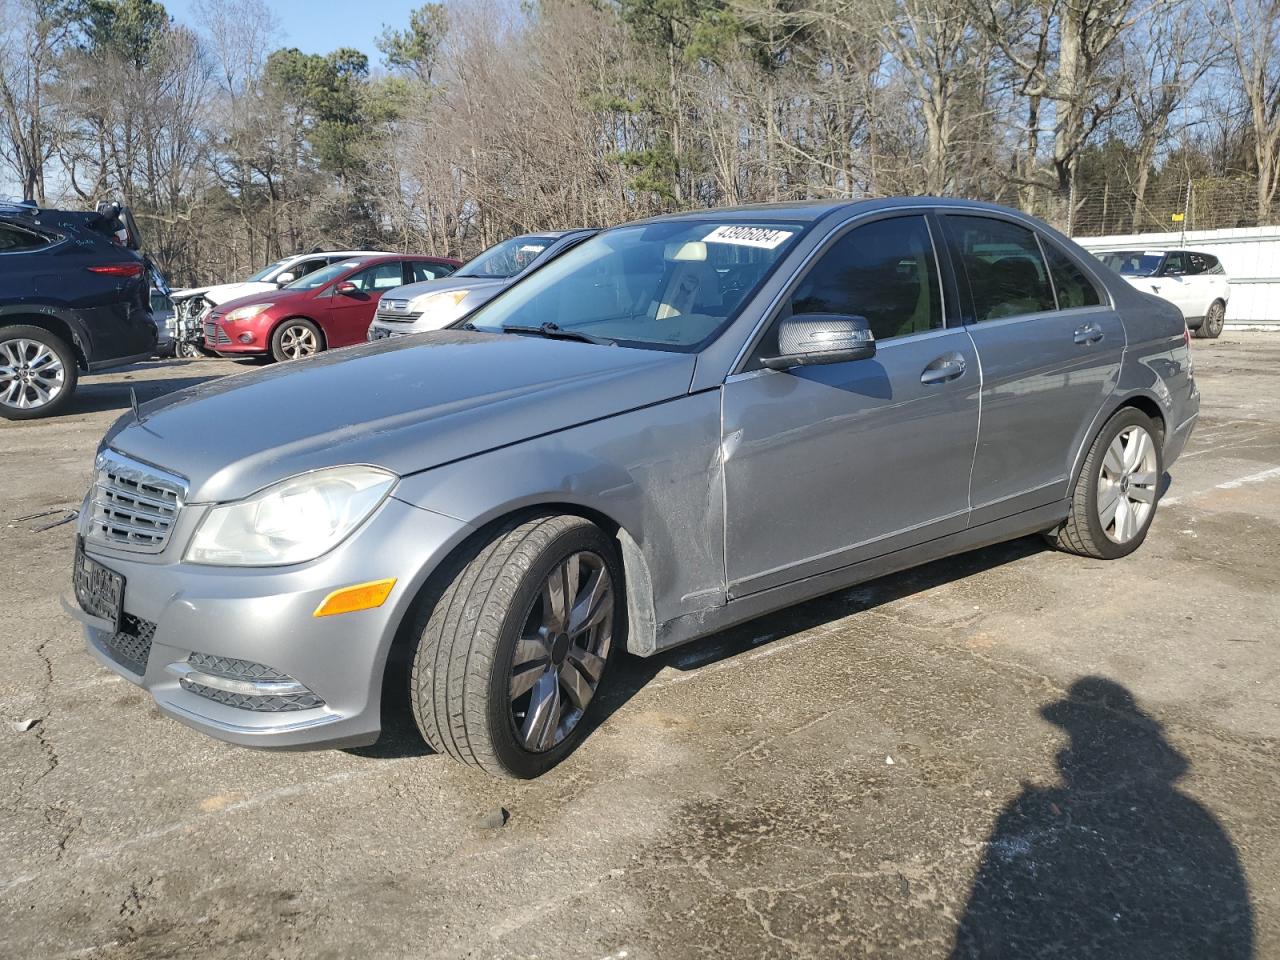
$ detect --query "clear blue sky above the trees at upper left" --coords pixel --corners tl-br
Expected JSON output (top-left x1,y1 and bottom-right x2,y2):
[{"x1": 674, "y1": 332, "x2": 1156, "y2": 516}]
[{"x1": 163, "y1": 0, "x2": 425, "y2": 67}]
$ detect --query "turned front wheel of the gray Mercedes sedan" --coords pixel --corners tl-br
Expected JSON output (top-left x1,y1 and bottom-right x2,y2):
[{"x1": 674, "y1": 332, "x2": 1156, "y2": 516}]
[{"x1": 410, "y1": 515, "x2": 625, "y2": 778}]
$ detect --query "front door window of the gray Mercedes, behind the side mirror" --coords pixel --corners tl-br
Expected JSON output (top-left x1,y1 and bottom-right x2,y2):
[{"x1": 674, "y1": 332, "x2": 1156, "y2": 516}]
[{"x1": 783, "y1": 216, "x2": 942, "y2": 340}]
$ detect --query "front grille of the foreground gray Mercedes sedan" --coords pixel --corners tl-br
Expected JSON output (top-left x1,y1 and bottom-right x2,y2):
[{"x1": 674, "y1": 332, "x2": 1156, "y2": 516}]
[{"x1": 84, "y1": 449, "x2": 187, "y2": 553}]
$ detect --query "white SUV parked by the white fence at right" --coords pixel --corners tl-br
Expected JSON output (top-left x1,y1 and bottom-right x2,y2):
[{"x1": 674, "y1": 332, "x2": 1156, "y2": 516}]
[{"x1": 1097, "y1": 250, "x2": 1231, "y2": 339}]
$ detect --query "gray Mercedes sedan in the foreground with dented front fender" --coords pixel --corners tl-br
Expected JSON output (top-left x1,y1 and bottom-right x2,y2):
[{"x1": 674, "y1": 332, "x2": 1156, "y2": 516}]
[{"x1": 64, "y1": 198, "x2": 1199, "y2": 777}]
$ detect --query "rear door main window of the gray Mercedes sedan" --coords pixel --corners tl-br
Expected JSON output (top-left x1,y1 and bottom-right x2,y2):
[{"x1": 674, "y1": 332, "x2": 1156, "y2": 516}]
[{"x1": 947, "y1": 216, "x2": 1057, "y2": 323}]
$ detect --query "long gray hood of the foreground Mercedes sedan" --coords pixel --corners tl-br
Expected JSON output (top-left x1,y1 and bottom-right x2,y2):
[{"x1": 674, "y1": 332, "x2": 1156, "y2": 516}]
[{"x1": 102, "y1": 330, "x2": 694, "y2": 503}]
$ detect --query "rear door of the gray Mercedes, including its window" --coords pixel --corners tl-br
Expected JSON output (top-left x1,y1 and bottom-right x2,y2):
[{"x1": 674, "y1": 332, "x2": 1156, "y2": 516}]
[{"x1": 943, "y1": 214, "x2": 1125, "y2": 525}]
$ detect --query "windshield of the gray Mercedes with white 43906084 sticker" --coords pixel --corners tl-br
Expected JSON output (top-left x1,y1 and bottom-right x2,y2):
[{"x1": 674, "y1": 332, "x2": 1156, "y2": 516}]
[{"x1": 467, "y1": 220, "x2": 804, "y2": 352}]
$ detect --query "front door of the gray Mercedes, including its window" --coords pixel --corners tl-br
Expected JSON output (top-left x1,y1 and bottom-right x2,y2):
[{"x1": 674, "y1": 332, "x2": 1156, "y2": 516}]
[{"x1": 723, "y1": 215, "x2": 979, "y2": 598}]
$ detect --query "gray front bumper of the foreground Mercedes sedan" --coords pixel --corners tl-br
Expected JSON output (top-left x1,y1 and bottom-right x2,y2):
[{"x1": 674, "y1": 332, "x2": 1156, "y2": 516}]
[{"x1": 63, "y1": 498, "x2": 470, "y2": 749}]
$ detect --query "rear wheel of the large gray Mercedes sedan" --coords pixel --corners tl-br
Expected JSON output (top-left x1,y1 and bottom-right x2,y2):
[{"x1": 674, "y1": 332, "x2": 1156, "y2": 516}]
[{"x1": 1047, "y1": 407, "x2": 1165, "y2": 559}]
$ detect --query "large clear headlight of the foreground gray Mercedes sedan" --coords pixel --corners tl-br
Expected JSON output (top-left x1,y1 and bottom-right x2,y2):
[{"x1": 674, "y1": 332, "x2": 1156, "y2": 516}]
[{"x1": 187, "y1": 466, "x2": 397, "y2": 567}]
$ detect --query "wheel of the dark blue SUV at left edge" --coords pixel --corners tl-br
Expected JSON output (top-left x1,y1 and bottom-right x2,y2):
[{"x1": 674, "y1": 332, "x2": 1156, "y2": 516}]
[{"x1": 0, "y1": 325, "x2": 79, "y2": 420}]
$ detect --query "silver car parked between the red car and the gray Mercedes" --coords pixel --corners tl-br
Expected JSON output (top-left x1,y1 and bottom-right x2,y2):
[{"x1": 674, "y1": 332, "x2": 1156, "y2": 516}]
[{"x1": 369, "y1": 228, "x2": 596, "y2": 340}]
